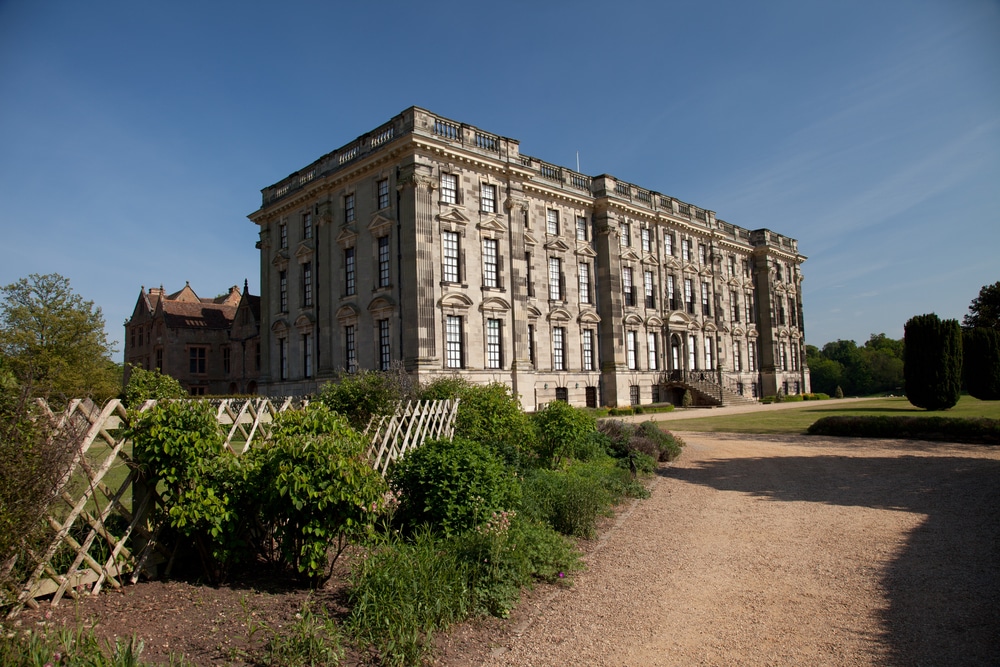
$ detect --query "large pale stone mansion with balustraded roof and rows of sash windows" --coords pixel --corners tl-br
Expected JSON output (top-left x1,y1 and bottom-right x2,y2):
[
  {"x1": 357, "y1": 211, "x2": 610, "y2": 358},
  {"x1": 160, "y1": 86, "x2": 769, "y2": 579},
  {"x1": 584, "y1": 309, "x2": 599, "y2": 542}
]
[{"x1": 249, "y1": 107, "x2": 809, "y2": 410}]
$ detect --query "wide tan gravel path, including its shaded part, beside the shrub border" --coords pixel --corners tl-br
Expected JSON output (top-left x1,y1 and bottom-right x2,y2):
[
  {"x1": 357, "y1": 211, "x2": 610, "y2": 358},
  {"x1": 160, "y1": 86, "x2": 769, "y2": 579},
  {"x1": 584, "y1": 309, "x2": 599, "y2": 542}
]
[{"x1": 474, "y1": 424, "x2": 1000, "y2": 666}]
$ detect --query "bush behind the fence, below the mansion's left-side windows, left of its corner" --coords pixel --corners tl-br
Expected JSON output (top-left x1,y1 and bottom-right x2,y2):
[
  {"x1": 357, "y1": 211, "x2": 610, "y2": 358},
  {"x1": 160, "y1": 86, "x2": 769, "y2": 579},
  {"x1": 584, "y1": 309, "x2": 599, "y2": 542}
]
[{"x1": 317, "y1": 366, "x2": 416, "y2": 431}]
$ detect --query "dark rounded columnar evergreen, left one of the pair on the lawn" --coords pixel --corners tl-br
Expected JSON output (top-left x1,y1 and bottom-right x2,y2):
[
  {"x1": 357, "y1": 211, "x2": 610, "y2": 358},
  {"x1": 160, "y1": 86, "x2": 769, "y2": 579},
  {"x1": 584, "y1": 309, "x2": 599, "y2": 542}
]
[{"x1": 903, "y1": 313, "x2": 962, "y2": 410}]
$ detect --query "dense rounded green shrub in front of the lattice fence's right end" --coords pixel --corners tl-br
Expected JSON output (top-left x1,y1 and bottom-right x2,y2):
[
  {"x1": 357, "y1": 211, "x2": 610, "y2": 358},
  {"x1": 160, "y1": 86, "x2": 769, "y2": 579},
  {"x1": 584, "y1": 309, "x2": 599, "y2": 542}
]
[{"x1": 390, "y1": 437, "x2": 520, "y2": 535}]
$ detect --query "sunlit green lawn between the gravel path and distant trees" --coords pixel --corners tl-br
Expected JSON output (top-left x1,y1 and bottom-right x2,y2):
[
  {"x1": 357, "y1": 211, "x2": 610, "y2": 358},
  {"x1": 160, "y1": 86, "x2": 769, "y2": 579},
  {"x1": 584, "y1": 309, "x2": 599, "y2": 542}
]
[{"x1": 651, "y1": 396, "x2": 1000, "y2": 433}]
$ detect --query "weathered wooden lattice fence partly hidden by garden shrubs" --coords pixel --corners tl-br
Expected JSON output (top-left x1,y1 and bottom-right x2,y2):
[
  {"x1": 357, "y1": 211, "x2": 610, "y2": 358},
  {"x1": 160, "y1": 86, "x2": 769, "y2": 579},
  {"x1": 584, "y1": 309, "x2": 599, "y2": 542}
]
[{"x1": 9, "y1": 398, "x2": 458, "y2": 616}]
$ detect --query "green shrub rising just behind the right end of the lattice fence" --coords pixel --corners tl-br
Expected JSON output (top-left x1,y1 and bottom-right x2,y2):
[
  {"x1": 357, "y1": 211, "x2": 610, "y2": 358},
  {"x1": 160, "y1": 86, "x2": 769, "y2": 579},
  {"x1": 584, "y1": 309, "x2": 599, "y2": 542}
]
[{"x1": 420, "y1": 377, "x2": 535, "y2": 467}]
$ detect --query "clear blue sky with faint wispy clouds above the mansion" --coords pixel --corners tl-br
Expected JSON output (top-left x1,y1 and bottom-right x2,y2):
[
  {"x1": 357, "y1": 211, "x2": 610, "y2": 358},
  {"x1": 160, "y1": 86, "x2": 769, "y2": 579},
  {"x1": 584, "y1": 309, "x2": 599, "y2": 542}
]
[{"x1": 0, "y1": 0, "x2": 1000, "y2": 359}]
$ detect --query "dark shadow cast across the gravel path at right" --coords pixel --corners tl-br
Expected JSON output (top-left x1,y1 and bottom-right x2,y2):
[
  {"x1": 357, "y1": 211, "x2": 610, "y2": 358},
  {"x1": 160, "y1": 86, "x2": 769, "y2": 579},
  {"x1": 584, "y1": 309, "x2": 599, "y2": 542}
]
[{"x1": 661, "y1": 444, "x2": 1000, "y2": 665}]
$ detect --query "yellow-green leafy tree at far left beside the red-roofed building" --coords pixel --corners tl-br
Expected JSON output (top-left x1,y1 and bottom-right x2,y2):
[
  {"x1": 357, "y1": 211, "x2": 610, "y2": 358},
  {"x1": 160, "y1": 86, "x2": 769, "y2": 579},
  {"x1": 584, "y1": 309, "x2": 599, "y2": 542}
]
[{"x1": 0, "y1": 273, "x2": 121, "y2": 401}]
